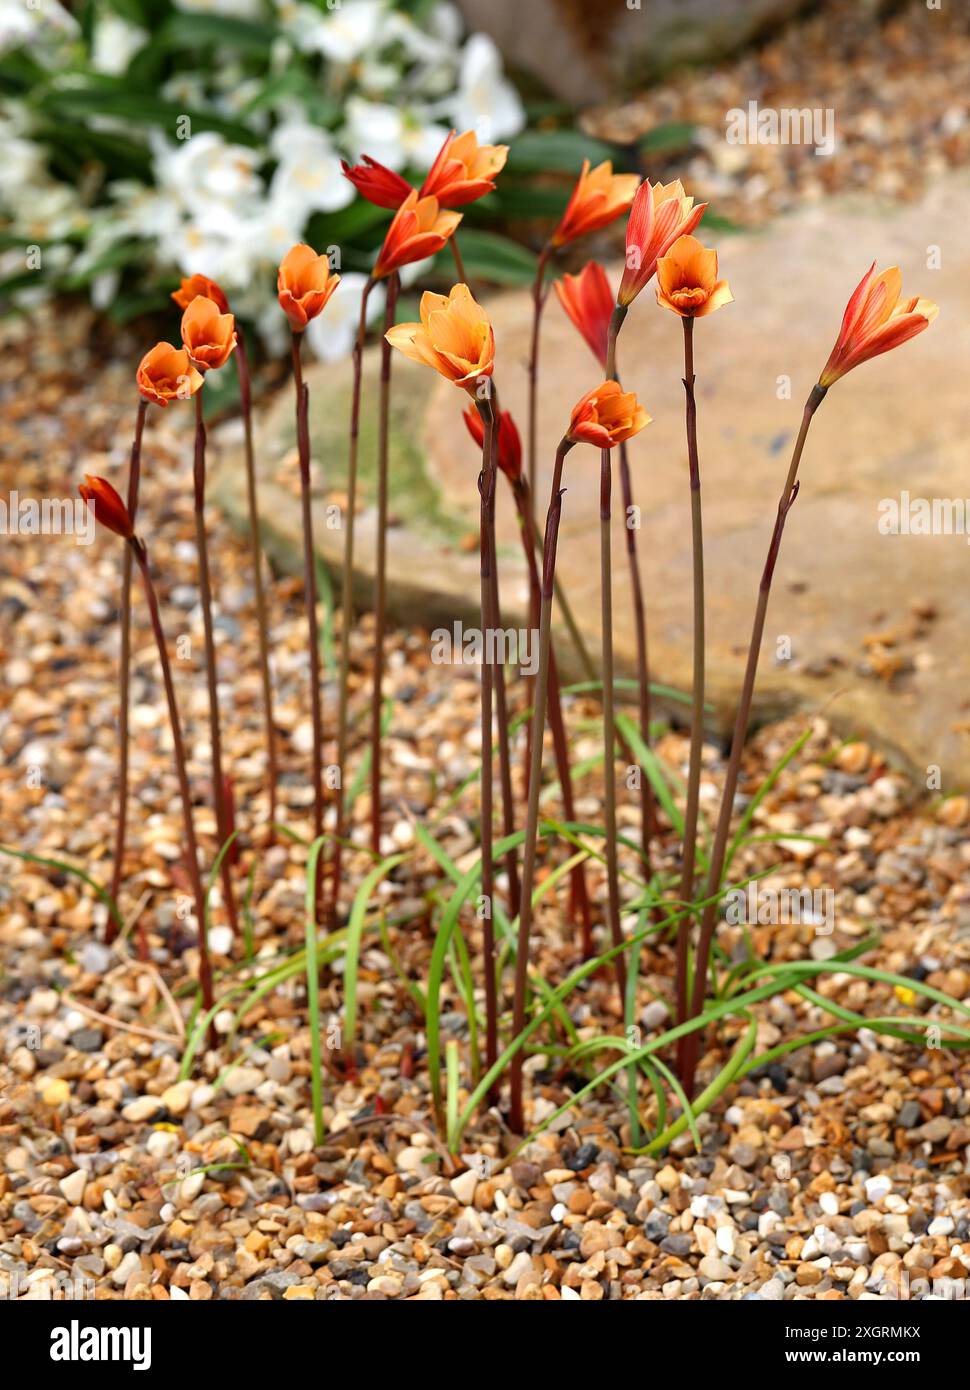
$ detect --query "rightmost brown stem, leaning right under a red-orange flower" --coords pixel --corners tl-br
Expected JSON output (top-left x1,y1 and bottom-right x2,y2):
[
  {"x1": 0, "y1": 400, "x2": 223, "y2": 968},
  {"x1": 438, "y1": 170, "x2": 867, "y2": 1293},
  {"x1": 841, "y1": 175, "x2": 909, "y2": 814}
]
[{"x1": 681, "y1": 386, "x2": 825, "y2": 1097}]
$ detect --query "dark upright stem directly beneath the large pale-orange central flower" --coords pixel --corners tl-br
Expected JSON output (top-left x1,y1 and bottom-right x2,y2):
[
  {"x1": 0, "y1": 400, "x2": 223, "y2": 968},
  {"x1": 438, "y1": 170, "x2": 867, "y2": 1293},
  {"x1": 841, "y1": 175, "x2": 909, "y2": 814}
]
[{"x1": 478, "y1": 384, "x2": 499, "y2": 1084}]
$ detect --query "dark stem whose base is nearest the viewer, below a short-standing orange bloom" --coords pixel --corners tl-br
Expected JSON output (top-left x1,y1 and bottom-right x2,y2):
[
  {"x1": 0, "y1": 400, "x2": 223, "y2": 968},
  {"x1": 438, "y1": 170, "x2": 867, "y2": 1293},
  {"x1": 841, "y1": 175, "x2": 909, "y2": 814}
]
[{"x1": 509, "y1": 438, "x2": 573, "y2": 1134}]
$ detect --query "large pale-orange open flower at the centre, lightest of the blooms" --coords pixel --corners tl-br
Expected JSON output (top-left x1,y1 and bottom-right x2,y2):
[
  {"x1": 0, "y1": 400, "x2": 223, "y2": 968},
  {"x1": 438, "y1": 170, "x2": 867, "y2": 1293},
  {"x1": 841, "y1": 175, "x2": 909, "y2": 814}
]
[{"x1": 385, "y1": 284, "x2": 495, "y2": 391}]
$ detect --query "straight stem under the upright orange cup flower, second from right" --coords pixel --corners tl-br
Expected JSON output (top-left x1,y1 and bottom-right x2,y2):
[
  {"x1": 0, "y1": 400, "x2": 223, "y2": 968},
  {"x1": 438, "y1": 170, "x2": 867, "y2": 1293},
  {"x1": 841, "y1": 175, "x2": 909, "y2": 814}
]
[{"x1": 677, "y1": 318, "x2": 705, "y2": 1036}]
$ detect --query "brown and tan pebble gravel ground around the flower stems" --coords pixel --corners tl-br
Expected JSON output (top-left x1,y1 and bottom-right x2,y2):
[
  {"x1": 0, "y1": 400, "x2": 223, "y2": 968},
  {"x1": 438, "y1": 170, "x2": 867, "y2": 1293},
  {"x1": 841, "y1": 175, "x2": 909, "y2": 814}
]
[{"x1": 0, "y1": 301, "x2": 970, "y2": 1300}]
